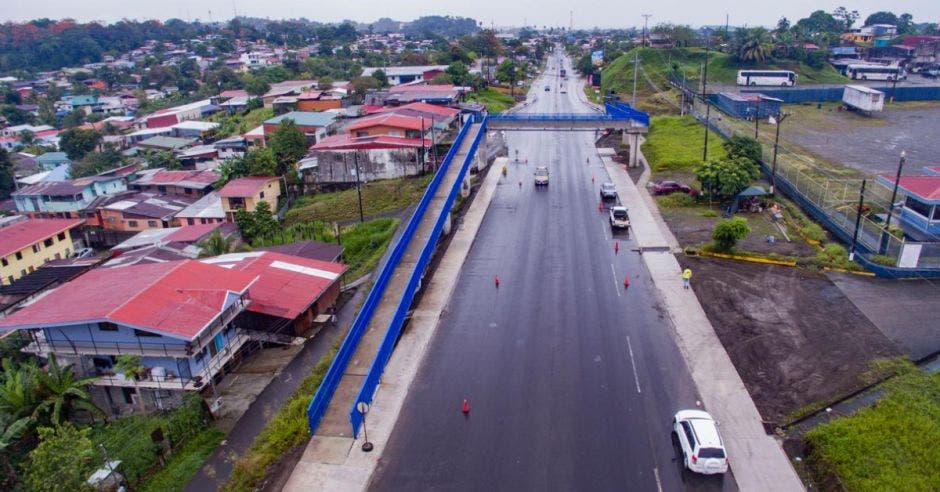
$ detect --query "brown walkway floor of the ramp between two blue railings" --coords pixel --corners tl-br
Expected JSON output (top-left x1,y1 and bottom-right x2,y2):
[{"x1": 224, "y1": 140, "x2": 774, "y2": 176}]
[{"x1": 314, "y1": 123, "x2": 483, "y2": 439}]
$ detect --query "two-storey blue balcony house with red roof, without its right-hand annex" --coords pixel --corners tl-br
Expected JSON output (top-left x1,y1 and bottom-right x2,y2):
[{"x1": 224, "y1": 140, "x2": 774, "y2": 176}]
[{"x1": 0, "y1": 260, "x2": 255, "y2": 413}]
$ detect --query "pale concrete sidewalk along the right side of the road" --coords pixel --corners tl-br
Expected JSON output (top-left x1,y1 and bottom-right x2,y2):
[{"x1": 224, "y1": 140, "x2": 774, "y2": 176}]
[{"x1": 604, "y1": 154, "x2": 803, "y2": 491}]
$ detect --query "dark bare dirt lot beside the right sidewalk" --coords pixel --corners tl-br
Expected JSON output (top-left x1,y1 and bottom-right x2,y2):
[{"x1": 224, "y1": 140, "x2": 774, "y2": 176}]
[{"x1": 679, "y1": 256, "x2": 901, "y2": 423}]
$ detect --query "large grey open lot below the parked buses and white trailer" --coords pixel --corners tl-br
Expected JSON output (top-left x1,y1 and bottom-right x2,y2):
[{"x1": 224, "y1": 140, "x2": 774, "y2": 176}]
[{"x1": 784, "y1": 102, "x2": 940, "y2": 174}]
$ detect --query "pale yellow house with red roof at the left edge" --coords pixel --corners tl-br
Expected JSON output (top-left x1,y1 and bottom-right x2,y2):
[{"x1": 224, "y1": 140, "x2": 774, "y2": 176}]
[{"x1": 0, "y1": 216, "x2": 84, "y2": 285}]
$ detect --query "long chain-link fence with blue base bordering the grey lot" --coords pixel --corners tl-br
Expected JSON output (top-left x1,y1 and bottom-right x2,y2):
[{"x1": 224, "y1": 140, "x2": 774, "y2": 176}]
[{"x1": 673, "y1": 80, "x2": 940, "y2": 269}]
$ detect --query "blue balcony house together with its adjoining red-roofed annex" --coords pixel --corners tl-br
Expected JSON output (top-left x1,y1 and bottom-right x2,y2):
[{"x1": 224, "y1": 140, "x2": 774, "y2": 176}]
[{"x1": 0, "y1": 251, "x2": 346, "y2": 413}]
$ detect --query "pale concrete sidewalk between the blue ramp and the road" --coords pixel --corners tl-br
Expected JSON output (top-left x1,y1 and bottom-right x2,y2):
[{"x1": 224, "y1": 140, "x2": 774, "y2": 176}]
[{"x1": 283, "y1": 154, "x2": 500, "y2": 492}]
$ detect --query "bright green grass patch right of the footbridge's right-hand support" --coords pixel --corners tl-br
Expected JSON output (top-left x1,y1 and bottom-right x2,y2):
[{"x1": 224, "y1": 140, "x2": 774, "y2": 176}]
[{"x1": 641, "y1": 116, "x2": 725, "y2": 172}]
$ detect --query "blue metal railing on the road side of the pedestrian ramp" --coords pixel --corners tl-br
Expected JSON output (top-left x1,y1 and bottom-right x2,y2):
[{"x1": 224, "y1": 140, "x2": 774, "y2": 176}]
[{"x1": 349, "y1": 114, "x2": 487, "y2": 436}]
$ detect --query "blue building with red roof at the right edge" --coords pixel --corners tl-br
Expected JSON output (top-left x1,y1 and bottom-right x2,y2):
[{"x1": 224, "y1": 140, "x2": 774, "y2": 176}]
[{"x1": 877, "y1": 166, "x2": 940, "y2": 242}]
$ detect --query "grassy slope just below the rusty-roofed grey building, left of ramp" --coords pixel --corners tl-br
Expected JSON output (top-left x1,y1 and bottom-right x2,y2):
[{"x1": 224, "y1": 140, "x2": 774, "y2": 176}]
[{"x1": 284, "y1": 174, "x2": 433, "y2": 226}]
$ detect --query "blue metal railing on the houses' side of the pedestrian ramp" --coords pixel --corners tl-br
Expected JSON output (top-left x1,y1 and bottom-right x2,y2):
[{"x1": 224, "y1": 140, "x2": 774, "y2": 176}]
[{"x1": 307, "y1": 115, "x2": 482, "y2": 435}]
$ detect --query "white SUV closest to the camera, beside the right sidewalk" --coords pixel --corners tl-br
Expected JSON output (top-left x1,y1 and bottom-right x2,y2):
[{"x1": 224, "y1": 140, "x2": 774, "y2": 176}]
[{"x1": 672, "y1": 410, "x2": 728, "y2": 475}]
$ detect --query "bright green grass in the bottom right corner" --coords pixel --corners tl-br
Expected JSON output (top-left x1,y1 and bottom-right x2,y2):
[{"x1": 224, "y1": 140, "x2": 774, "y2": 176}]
[{"x1": 806, "y1": 364, "x2": 940, "y2": 491}]
